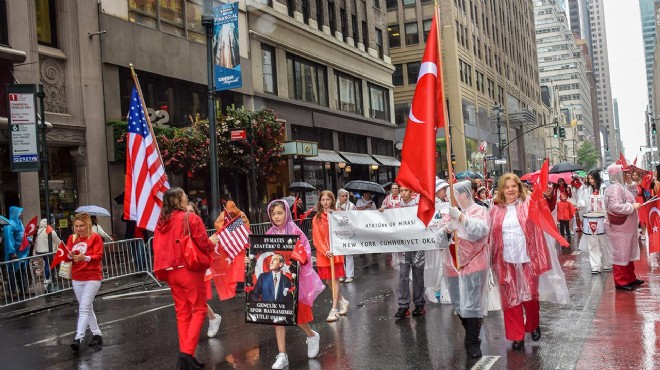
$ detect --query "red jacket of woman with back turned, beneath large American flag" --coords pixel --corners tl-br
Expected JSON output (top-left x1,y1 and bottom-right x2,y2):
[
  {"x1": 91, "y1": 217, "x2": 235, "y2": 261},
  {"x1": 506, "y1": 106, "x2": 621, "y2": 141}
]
[{"x1": 153, "y1": 210, "x2": 213, "y2": 280}]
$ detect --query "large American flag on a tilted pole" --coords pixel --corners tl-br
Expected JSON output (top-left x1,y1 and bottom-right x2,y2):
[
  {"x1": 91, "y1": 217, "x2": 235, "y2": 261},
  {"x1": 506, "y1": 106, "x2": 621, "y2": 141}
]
[{"x1": 124, "y1": 87, "x2": 170, "y2": 231}]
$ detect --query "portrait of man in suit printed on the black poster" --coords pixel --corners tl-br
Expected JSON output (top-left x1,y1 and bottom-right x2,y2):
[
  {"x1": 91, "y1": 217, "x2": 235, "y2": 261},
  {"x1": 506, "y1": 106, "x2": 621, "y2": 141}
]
[{"x1": 252, "y1": 253, "x2": 293, "y2": 303}]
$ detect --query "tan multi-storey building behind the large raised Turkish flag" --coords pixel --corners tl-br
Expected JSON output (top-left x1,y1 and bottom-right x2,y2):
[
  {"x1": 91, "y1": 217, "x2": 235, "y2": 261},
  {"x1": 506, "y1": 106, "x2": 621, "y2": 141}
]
[{"x1": 387, "y1": 0, "x2": 547, "y2": 176}]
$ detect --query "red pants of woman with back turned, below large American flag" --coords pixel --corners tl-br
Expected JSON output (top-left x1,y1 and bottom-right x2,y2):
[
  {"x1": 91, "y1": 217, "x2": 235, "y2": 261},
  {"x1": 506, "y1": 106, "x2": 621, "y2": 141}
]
[{"x1": 165, "y1": 268, "x2": 206, "y2": 356}]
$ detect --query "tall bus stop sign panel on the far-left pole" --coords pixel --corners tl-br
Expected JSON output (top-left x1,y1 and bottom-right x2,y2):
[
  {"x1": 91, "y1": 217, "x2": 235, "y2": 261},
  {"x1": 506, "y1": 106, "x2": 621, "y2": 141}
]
[{"x1": 7, "y1": 84, "x2": 40, "y2": 172}]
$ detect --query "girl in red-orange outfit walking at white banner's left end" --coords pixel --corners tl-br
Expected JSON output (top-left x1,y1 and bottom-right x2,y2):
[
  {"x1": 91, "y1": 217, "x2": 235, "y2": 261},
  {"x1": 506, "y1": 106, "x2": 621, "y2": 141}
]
[{"x1": 312, "y1": 190, "x2": 349, "y2": 322}]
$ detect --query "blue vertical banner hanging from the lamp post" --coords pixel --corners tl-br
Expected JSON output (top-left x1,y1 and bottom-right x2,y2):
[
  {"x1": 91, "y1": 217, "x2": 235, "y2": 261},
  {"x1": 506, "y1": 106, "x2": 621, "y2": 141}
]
[{"x1": 213, "y1": 2, "x2": 243, "y2": 91}]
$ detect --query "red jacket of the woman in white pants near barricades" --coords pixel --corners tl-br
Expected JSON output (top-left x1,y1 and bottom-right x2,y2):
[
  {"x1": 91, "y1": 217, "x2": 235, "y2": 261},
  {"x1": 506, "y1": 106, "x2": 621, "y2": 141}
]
[{"x1": 66, "y1": 233, "x2": 103, "y2": 281}]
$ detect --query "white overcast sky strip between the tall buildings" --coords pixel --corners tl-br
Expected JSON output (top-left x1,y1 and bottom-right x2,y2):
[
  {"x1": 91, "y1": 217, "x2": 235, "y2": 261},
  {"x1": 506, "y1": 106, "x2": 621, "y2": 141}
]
[{"x1": 604, "y1": 0, "x2": 647, "y2": 161}]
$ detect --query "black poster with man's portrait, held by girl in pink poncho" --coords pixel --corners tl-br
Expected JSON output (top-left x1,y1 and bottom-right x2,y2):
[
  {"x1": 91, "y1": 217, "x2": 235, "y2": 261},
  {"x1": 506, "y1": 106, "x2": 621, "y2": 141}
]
[{"x1": 245, "y1": 235, "x2": 298, "y2": 326}]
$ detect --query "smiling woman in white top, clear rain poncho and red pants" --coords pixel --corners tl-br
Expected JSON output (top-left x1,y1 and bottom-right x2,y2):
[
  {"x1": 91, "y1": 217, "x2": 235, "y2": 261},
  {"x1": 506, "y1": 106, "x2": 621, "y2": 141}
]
[{"x1": 490, "y1": 173, "x2": 552, "y2": 350}]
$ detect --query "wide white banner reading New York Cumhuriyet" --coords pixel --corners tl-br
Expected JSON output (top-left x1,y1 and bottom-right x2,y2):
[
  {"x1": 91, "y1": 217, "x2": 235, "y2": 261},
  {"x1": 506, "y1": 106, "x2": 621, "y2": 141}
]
[{"x1": 329, "y1": 207, "x2": 440, "y2": 255}]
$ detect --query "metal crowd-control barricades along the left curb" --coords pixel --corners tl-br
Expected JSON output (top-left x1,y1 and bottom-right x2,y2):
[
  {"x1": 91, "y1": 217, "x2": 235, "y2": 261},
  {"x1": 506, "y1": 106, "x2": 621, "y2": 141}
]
[{"x1": 0, "y1": 239, "x2": 160, "y2": 307}]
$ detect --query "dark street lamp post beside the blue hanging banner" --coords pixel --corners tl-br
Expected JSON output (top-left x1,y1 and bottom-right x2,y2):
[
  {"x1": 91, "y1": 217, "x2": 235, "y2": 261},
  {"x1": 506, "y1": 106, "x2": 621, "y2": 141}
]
[{"x1": 202, "y1": 0, "x2": 220, "y2": 226}]
